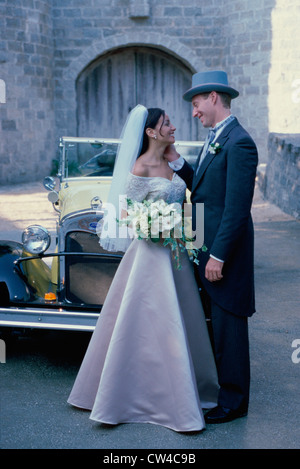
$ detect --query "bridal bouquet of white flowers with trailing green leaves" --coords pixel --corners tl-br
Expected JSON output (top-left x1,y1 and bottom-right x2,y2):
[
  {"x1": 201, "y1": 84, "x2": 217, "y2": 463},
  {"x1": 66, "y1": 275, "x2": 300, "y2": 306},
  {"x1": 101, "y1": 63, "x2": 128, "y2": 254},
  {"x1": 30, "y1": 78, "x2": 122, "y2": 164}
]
[{"x1": 119, "y1": 199, "x2": 203, "y2": 269}]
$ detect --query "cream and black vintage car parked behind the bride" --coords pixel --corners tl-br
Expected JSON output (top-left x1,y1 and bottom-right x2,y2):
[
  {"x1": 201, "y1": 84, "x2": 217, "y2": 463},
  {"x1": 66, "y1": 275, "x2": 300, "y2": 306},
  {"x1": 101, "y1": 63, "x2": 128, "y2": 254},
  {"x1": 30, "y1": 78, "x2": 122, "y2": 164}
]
[{"x1": 0, "y1": 137, "x2": 202, "y2": 331}]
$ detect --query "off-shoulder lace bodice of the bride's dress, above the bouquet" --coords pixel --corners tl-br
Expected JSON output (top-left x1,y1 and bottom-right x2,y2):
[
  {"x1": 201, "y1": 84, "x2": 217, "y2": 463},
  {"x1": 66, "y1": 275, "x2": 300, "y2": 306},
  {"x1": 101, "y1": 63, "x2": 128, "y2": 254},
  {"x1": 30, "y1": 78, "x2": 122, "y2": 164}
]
[{"x1": 126, "y1": 173, "x2": 186, "y2": 204}]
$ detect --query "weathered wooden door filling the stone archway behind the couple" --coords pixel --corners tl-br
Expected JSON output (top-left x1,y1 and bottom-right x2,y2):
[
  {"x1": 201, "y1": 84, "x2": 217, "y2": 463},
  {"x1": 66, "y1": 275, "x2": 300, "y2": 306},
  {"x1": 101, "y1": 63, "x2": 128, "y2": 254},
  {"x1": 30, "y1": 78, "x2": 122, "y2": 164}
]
[{"x1": 76, "y1": 46, "x2": 199, "y2": 140}]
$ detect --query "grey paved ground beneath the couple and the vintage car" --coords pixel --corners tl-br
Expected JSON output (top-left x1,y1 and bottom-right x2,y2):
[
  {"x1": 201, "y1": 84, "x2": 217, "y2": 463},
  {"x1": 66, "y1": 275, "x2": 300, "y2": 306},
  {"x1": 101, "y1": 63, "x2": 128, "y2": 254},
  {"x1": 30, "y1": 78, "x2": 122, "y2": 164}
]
[{"x1": 0, "y1": 183, "x2": 300, "y2": 450}]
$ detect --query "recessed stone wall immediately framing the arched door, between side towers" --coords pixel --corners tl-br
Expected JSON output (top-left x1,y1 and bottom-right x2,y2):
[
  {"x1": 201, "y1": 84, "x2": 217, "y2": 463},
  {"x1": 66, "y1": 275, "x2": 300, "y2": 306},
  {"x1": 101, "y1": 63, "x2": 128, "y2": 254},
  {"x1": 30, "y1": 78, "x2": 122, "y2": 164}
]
[{"x1": 53, "y1": 0, "x2": 223, "y2": 143}]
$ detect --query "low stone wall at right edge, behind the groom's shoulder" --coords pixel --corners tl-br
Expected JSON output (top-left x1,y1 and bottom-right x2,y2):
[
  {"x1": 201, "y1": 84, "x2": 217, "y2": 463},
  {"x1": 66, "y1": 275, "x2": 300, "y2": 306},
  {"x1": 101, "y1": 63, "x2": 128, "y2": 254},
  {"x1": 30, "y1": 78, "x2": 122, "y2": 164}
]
[{"x1": 259, "y1": 133, "x2": 300, "y2": 220}]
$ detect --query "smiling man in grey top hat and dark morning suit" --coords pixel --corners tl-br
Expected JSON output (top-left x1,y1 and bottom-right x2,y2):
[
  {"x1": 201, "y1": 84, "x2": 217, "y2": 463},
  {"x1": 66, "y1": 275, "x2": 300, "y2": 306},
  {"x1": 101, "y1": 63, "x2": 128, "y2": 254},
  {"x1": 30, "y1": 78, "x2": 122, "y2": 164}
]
[{"x1": 166, "y1": 71, "x2": 258, "y2": 423}]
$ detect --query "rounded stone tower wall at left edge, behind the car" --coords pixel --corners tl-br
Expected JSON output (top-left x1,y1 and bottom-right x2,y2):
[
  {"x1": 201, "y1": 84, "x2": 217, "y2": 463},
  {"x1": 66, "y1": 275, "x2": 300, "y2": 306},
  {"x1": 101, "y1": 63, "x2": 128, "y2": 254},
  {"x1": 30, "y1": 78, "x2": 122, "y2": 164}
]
[{"x1": 0, "y1": 0, "x2": 55, "y2": 184}]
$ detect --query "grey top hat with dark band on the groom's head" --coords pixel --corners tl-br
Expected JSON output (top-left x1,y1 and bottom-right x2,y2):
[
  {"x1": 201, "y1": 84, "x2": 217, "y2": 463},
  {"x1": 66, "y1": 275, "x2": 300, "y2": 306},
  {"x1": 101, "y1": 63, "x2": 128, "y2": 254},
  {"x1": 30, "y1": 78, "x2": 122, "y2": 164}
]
[{"x1": 183, "y1": 71, "x2": 239, "y2": 101}]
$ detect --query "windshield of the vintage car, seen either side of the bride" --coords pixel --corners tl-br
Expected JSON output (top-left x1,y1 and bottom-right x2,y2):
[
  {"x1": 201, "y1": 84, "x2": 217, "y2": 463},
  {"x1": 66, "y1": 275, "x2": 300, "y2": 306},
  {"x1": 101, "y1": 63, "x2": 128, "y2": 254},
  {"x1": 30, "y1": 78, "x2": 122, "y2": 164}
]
[{"x1": 59, "y1": 137, "x2": 203, "y2": 179}]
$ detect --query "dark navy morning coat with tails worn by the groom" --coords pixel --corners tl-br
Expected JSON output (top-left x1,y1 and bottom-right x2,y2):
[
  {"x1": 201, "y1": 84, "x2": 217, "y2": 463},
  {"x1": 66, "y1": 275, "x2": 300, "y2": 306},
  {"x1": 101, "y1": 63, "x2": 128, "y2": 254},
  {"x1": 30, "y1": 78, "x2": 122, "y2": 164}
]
[{"x1": 178, "y1": 119, "x2": 258, "y2": 316}]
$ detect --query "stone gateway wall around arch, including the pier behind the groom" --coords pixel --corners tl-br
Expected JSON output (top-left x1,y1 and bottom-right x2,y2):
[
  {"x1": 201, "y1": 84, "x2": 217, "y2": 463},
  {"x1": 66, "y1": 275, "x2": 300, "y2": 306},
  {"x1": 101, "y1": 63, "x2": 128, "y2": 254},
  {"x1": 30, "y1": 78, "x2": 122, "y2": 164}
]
[{"x1": 53, "y1": 0, "x2": 276, "y2": 161}]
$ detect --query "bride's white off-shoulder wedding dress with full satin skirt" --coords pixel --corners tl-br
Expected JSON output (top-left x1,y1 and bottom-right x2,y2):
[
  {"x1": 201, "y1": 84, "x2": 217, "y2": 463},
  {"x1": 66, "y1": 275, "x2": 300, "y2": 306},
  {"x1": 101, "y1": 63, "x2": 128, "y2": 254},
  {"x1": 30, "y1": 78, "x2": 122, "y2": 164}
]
[{"x1": 68, "y1": 173, "x2": 218, "y2": 432}]
